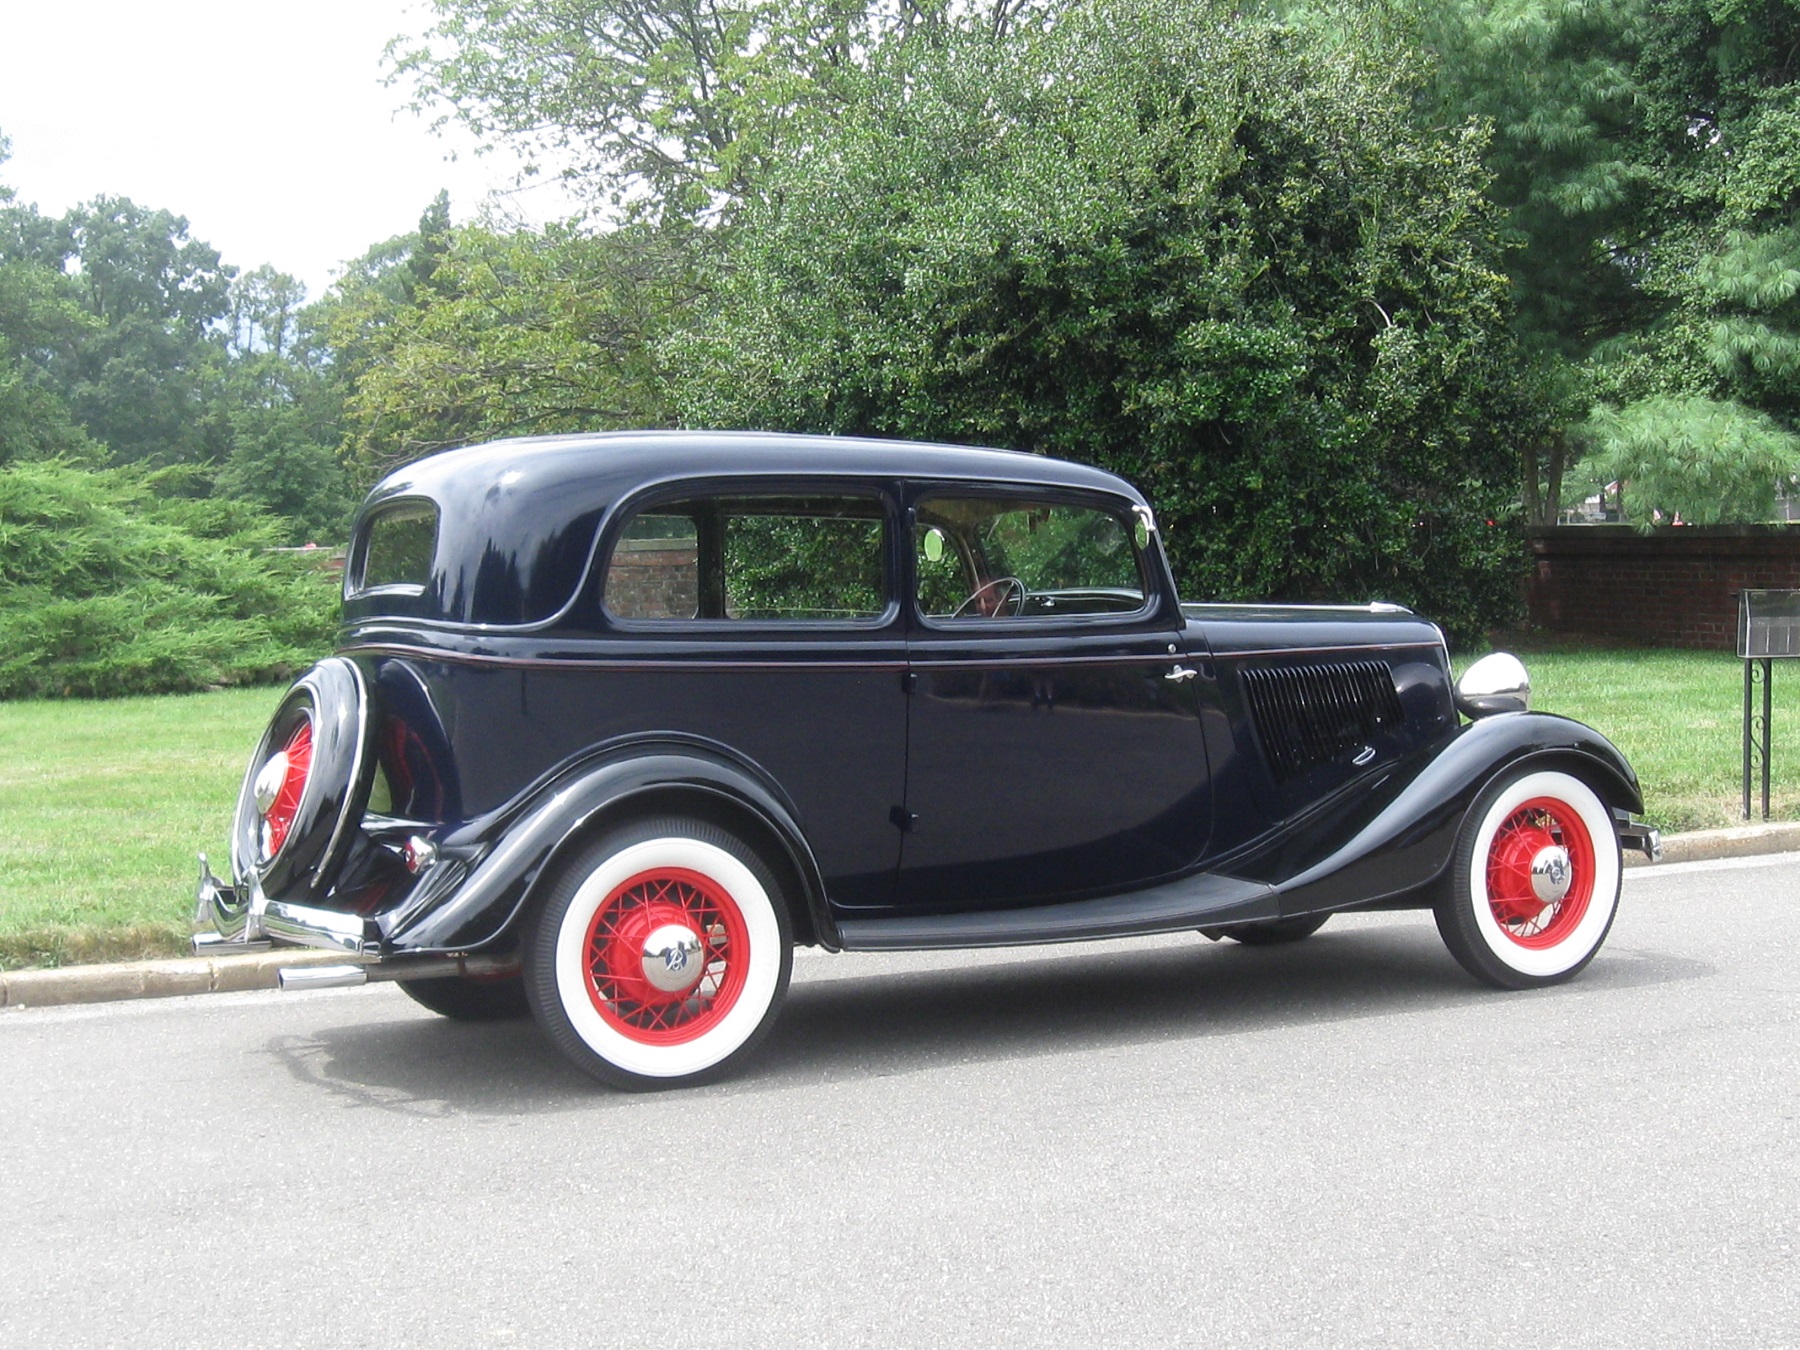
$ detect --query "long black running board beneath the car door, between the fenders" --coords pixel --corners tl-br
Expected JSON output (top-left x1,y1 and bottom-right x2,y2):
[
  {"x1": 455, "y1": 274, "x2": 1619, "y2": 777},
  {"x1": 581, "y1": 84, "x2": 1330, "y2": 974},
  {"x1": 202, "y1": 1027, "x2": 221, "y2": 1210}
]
[{"x1": 837, "y1": 873, "x2": 1282, "y2": 952}]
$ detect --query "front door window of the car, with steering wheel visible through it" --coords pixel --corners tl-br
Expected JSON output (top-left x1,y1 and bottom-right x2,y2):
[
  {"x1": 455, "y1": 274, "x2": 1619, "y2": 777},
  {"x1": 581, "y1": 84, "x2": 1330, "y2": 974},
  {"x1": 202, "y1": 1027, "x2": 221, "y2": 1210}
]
[{"x1": 914, "y1": 497, "x2": 1148, "y2": 619}]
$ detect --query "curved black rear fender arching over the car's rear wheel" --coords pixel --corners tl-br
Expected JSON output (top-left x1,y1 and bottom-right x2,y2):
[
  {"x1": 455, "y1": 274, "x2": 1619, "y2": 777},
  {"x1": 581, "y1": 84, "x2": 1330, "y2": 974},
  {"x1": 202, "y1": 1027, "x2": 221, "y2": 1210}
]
[{"x1": 380, "y1": 745, "x2": 837, "y2": 952}]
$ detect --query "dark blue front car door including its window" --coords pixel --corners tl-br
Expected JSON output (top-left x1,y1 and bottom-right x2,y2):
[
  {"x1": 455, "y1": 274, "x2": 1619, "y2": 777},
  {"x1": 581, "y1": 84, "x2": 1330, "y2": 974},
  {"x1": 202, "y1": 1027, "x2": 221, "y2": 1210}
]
[{"x1": 896, "y1": 486, "x2": 1211, "y2": 913}]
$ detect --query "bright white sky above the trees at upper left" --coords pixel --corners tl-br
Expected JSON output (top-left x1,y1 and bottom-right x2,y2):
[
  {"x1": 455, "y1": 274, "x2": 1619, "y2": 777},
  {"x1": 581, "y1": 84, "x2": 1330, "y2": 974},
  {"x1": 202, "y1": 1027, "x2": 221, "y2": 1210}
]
[{"x1": 0, "y1": 0, "x2": 572, "y2": 297}]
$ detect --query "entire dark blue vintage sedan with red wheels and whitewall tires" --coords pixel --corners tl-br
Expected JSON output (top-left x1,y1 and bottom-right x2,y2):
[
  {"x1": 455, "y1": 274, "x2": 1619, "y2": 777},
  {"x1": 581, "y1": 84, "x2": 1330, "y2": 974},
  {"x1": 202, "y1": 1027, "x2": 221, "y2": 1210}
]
[{"x1": 194, "y1": 432, "x2": 1658, "y2": 1087}]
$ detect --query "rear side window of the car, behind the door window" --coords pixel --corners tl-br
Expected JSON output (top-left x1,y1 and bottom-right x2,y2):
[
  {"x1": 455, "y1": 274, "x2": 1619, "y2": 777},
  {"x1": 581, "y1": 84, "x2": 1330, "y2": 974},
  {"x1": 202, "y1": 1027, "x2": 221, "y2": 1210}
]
[{"x1": 605, "y1": 495, "x2": 887, "y2": 621}]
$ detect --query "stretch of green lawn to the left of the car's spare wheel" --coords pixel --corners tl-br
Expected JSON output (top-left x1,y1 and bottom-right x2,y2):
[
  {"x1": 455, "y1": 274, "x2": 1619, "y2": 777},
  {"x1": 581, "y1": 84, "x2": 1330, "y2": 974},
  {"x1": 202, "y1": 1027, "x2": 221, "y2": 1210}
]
[{"x1": 0, "y1": 688, "x2": 281, "y2": 968}]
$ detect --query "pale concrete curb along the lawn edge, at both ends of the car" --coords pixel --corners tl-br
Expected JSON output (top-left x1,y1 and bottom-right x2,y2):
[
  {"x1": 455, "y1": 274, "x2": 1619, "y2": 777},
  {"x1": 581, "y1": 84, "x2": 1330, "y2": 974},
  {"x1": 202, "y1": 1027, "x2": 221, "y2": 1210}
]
[{"x1": 0, "y1": 823, "x2": 1800, "y2": 1008}]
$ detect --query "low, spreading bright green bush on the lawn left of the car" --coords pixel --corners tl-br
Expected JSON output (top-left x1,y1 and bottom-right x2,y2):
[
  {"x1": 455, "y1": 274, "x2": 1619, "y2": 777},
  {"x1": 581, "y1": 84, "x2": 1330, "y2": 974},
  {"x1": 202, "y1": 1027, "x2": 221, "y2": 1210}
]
[{"x1": 0, "y1": 461, "x2": 337, "y2": 698}]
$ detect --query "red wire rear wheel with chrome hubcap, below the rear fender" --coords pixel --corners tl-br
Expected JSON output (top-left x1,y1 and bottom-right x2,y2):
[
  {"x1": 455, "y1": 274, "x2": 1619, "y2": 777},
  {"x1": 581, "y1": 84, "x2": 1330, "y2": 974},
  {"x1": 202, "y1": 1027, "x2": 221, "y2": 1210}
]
[{"x1": 587, "y1": 868, "x2": 749, "y2": 1046}]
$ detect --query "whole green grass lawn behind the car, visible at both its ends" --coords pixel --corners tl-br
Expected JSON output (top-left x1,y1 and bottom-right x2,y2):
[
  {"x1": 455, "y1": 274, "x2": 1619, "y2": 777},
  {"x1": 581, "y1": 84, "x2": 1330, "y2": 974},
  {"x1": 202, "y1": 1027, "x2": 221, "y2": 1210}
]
[{"x1": 0, "y1": 648, "x2": 1800, "y2": 968}]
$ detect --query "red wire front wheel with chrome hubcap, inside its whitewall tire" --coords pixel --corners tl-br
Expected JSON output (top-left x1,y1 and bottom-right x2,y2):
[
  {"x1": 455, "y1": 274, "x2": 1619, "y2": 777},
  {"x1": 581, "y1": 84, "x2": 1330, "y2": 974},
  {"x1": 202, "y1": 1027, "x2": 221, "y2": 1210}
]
[{"x1": 1487, "y1": 797, "x2": 1593, "y2": 950}]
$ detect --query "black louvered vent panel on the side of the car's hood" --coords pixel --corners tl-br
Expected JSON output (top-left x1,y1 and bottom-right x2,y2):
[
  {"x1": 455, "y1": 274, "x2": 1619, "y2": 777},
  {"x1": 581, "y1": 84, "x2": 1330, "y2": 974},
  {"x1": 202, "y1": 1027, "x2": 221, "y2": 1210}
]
[{"x1": 1240, "y1": 661, "x2": 1404, "y2": 781}]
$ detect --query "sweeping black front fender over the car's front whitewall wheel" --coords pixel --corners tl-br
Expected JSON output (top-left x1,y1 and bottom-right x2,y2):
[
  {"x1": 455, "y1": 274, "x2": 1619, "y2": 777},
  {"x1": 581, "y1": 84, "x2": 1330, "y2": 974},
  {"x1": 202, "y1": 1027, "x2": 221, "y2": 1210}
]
[{"x1": 1260, "y1": 713, "x2": 1643, "y2": 914}]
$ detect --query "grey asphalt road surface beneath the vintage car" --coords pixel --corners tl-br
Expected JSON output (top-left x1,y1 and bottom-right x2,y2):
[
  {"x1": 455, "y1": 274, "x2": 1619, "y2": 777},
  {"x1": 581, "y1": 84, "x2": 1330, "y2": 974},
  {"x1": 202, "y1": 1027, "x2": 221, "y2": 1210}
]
[{"x1": 0, "y1": 855, "x2": 1800, "y2": 1350}]
